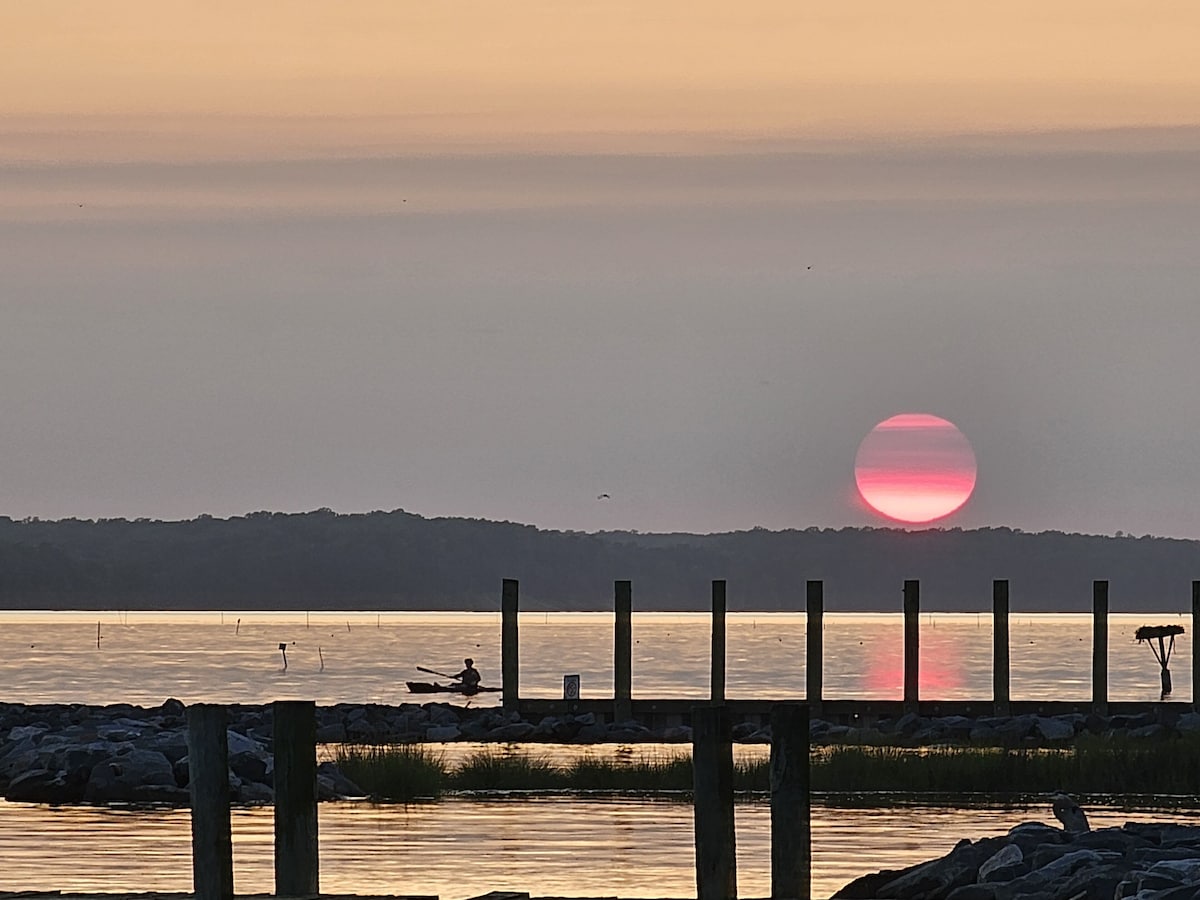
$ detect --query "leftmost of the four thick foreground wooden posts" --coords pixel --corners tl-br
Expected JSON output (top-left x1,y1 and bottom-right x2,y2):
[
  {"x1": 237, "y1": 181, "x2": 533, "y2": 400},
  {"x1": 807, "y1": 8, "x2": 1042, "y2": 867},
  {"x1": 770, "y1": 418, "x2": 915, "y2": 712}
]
[{"x1": 187, "y1": 703, "x2": 233, "y2": 900}]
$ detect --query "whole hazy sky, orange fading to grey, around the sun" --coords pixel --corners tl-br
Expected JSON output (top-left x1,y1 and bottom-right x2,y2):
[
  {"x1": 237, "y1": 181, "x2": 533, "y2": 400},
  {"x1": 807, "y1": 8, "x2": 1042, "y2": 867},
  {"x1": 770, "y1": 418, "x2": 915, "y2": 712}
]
[{"x1": 0, "y1": 0, "x2": 1200, "y2": 538}]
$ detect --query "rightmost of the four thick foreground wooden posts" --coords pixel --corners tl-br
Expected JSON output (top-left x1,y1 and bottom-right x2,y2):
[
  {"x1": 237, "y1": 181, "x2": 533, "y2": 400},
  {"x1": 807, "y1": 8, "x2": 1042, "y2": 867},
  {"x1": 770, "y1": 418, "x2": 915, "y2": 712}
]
[{"x1": 769, "y1": 703, "x2": 812, "y2": 900}]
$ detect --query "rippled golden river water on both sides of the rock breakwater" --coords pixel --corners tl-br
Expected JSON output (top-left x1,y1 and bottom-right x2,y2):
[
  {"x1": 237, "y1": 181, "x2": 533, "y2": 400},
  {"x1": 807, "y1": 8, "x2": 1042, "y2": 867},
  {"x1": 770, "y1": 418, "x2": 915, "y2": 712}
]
[{"x1": 0, "y1": 612, "x2": 1192, "y2": 900}]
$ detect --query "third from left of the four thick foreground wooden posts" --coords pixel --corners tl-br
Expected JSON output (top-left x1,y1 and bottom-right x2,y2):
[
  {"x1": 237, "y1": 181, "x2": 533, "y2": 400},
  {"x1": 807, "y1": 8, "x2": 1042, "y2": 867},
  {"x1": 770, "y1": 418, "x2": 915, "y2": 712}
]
[{"x1": 691, "y1": 704, "x2": 738, "y2": 900}]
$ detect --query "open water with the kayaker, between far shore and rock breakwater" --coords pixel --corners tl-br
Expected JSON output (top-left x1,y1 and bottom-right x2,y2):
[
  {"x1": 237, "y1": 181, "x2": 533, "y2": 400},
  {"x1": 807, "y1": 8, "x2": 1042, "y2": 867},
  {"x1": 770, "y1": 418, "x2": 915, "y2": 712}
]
[{"x1": 0, "y1": 612, "x2": 1192, "y2": 704}]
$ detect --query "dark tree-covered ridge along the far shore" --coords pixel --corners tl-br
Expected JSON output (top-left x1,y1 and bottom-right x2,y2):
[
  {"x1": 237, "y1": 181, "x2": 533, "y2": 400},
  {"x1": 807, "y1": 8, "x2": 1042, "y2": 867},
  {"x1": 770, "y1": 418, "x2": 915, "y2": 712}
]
[{"x1": 0, "y1": 509, "x2": 1200, "y2": 612}]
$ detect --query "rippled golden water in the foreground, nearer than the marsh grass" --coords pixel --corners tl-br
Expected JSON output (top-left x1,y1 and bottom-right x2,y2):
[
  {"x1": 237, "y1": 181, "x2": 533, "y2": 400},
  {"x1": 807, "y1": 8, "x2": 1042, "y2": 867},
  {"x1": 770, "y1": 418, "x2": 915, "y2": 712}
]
[{"x1": 0, "y1": 798, "x2": 1193, "y2": 900}]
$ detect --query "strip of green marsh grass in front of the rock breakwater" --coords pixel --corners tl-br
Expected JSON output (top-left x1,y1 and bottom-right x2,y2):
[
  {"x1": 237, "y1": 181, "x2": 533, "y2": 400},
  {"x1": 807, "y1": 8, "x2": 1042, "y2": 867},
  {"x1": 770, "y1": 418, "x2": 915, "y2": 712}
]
[{"x1": 335, "y1": 736, "x2": 1200, "y2": 805}]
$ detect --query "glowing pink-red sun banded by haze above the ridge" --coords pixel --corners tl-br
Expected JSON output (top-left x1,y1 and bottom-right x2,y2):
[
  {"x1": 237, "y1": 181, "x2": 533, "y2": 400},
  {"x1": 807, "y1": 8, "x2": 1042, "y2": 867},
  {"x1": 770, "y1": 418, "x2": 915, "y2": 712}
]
[{"x1": 854, "y1": 413, "x2": 976, "y2": 523}]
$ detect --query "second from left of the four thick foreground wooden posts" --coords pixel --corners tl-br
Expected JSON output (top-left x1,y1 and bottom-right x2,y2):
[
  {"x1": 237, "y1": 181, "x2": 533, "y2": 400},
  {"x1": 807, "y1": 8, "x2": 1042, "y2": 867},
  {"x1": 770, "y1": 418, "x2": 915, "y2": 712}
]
[{"x1": 271, "y1": 700, "x2": 320, "y2": 896}]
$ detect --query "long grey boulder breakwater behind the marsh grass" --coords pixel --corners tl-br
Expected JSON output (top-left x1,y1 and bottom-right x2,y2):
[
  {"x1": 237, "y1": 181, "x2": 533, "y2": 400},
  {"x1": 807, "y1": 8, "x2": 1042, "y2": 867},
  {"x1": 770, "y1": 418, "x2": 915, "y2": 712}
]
[{"x1": 0, "y1": 700, "x2": 1200, "y2": 805}]
